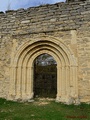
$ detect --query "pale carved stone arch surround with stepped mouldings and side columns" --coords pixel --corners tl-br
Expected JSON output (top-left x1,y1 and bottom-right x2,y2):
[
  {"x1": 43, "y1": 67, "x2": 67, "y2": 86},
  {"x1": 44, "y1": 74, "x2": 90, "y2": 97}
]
[{"x1": 9, "y1": 36, "x2": 78, "y2": 102}]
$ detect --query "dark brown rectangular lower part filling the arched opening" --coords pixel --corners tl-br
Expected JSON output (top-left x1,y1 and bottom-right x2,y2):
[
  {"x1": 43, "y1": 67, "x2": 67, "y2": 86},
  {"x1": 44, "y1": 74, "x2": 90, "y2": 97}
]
[{"x1": 34, "y1": 64, "x2": 57, "y2": 98}]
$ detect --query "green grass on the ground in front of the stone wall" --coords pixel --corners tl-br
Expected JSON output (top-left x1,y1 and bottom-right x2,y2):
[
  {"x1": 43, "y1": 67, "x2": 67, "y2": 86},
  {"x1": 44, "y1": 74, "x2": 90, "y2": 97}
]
[{"x1": 0, "y1": 99, "x2": 90, "y2": 120}]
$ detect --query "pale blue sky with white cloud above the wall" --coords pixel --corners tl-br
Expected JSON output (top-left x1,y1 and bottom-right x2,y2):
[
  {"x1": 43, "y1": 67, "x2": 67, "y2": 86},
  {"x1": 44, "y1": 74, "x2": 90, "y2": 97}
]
[{"x1": 0, "y1": 0, "x2": 65, "y2": 12}]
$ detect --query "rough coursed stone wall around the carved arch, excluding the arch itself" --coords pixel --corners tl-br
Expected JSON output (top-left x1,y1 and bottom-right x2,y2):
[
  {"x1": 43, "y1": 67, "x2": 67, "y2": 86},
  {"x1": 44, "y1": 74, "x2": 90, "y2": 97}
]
[{"x1": 0, "y1": 1, "x2": 90, "y2": 102}]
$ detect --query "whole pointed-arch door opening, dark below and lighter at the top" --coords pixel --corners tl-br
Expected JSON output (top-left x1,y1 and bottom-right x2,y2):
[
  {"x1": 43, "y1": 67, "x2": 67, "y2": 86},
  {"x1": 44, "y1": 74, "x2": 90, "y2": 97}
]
[{"x1": 33, "y1": 53, "x2": 57, "y2": 98}]
